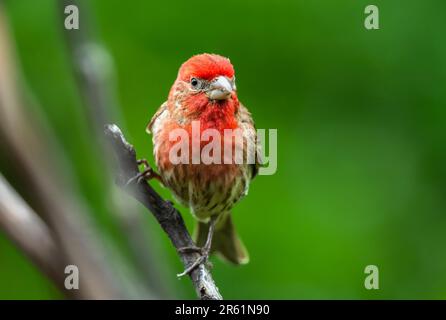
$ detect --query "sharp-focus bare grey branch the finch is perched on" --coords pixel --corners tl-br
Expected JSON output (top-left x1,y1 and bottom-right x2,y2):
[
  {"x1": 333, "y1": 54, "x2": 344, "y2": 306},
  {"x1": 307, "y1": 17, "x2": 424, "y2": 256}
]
[{"x1": 105, "y1": 124, "x2": 223, "y2": 300}]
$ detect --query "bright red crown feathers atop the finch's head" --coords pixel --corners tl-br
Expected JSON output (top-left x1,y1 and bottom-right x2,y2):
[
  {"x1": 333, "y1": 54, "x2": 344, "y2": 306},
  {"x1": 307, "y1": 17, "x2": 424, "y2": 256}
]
[{"x1": 178, "y1": 53, "x2": 234, "y2": 81}]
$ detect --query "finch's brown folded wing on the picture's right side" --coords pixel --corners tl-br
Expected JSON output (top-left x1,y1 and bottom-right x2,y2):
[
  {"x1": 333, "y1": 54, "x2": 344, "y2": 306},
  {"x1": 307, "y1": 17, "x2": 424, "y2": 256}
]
[{"x1": 236, "y1": 103, "x2": 263, "y2": 178}]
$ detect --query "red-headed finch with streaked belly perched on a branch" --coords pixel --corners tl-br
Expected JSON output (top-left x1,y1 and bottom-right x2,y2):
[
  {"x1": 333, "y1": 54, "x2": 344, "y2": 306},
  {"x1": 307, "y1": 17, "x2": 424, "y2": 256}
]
[{"x1": 146, "y1": 53, "x2": 261, "y2": 275}]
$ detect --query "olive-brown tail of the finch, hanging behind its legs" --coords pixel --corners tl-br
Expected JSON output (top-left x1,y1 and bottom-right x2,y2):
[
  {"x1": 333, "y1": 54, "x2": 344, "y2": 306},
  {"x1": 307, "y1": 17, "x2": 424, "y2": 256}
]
[{"x1": 194, "y1": 214, "x2": 249, "y2": 265}]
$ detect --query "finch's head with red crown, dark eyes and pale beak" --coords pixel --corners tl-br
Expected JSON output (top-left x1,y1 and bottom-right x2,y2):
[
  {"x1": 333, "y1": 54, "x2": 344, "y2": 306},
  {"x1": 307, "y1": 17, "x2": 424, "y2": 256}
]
[{"x1": 177, "y1": 53, "x2": 236, "y2": 101}]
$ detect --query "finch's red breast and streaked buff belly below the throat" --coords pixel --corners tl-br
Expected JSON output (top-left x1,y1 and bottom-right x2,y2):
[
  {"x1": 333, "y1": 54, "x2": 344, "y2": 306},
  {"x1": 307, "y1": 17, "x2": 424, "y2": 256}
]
[{"x1": 147, "y1": 103, "x2": 256, "y2": 219}]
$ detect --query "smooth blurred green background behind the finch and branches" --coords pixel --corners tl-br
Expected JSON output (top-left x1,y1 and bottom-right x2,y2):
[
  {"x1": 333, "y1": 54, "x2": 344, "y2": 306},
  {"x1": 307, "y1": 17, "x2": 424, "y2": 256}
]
[{"x1": 0, "y1": 0, "x2": 446, "y2": 299}]
